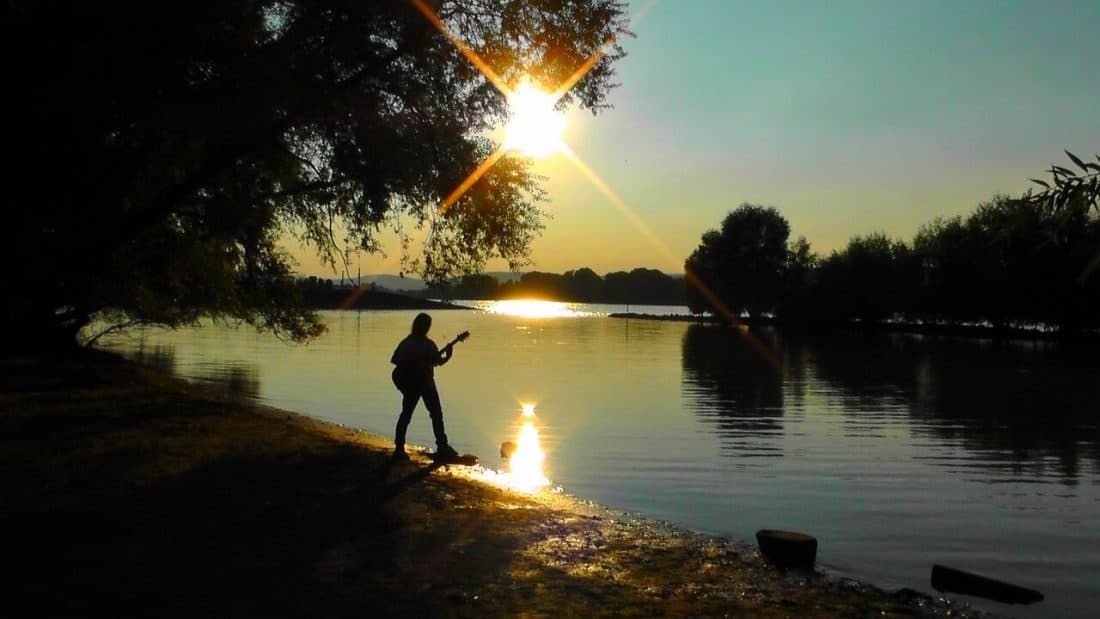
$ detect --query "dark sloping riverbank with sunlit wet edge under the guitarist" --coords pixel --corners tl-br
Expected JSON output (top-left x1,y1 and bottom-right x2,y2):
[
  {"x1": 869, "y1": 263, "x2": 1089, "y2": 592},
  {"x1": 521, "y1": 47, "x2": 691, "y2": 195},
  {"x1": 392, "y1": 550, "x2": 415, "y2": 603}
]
[{"x1": 0, "y1": 353, "x2": 981, "y2": 617}]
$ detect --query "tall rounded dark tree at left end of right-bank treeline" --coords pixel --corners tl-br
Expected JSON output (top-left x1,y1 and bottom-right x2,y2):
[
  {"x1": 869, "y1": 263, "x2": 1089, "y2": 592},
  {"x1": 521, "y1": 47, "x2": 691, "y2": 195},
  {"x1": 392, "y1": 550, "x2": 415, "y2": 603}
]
[{"x1": 684, "y1": 203, "x2": 791, "y2": 316}]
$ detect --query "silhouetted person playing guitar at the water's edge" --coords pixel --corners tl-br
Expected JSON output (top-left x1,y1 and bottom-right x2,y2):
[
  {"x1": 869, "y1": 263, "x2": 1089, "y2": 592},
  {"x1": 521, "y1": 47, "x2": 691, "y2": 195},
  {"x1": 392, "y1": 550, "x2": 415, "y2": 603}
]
[{"x1": 389, "y1": 312, "x2": 459, "y2": 462}]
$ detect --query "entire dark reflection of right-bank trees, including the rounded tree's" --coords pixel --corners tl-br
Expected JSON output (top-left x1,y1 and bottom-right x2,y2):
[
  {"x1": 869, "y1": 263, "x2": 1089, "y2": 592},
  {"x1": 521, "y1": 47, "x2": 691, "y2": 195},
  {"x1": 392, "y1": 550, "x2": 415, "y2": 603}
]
[{"x1": 683, "y1": 325, "x2": 1100, "y2": 485}]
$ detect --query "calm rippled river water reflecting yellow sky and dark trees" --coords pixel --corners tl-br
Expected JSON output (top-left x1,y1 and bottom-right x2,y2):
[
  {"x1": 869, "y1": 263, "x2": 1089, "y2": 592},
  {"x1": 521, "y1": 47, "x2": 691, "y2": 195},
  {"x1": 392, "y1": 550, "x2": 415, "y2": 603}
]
[{"x1": 96, "y1": 305, "x2": 1100, "y2": 617}]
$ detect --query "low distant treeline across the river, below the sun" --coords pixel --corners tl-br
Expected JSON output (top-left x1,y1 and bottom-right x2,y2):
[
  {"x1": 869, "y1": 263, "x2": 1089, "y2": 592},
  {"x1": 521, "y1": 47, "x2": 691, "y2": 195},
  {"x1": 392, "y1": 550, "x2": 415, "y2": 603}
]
[{"x1": 429, "y1": 267, "x2": 685, "y2": 306}]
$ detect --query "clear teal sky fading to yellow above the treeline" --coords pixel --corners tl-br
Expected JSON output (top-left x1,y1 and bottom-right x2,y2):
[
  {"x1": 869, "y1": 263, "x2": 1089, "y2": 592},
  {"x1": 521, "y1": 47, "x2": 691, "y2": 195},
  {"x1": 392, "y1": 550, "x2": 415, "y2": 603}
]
[{"x1": 290, "y1": 0, "x2": 1100, "y2": 277}]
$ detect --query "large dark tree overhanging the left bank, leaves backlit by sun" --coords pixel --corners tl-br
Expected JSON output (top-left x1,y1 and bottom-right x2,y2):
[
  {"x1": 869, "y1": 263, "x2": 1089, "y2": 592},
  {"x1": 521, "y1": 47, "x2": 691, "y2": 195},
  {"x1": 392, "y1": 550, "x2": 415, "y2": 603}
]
[{"x1": 0, "y1": 0, "x2": 626, "y2": 345}]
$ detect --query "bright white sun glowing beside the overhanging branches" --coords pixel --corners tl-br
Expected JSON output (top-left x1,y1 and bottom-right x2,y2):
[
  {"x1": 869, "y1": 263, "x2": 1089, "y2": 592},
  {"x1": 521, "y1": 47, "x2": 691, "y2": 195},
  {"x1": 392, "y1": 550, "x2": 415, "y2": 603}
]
[{"x1": 504, "y1": 81, "x2": 565, "y2": 158}]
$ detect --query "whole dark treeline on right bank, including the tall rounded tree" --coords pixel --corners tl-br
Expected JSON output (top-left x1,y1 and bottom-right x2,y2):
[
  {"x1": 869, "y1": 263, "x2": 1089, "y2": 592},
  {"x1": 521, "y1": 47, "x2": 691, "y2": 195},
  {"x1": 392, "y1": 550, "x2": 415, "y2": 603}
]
[{"x1": 685, "y1": 196, "x2": 1100, "y2": 332}]
